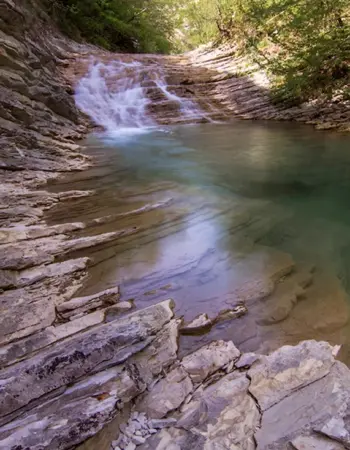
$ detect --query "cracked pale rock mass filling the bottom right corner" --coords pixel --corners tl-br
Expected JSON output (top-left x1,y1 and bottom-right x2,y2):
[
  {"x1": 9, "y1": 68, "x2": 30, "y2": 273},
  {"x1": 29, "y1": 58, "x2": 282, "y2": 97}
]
[{"x1": 79, "y1": 332, "x2": 350, "y2": 450}]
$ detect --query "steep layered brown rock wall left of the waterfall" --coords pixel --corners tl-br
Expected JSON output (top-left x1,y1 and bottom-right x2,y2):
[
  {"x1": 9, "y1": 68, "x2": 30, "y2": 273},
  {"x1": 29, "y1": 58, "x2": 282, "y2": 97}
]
[{"x1": 0, "y1": 0, "x2": 87, "y2": 226}]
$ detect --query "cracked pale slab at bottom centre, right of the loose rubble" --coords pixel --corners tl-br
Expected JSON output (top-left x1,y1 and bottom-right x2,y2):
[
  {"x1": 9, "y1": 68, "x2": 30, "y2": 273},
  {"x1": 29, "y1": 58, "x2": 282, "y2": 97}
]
[{"x1": 145, "y1": 373, "x2": 260, "y2": 450}]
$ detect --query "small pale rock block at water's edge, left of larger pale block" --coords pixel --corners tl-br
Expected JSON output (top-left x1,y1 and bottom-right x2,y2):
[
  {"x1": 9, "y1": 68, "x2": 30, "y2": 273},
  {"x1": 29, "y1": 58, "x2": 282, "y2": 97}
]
[{"x1": 181, "y1": 341, "x2": 240, "y2": 383}]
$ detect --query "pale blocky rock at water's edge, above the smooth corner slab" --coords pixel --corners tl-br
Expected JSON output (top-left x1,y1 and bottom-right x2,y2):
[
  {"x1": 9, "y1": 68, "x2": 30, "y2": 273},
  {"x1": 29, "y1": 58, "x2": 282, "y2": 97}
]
[{"x1": 248, "y1": 341, "x2": 334, "y2": 411}]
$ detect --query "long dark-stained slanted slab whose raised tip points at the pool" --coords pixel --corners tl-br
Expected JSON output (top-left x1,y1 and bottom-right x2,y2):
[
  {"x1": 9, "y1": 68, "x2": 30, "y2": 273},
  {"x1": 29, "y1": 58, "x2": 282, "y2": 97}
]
[{"x1": 0, "y1": 300, "x2": 173, "y2": 420}]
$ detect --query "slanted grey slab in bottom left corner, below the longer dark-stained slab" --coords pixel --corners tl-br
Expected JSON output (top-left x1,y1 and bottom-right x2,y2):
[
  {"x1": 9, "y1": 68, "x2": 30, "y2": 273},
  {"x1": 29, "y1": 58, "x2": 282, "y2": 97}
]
[{"x1": 0, "y1": 366, "x2": 140, "y2": 449}]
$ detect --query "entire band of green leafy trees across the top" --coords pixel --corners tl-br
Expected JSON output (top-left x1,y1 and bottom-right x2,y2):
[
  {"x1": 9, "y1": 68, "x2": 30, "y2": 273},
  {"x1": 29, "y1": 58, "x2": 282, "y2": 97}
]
[{"x1": 43, "y1": 0, "x2": 350, "y2": 102}]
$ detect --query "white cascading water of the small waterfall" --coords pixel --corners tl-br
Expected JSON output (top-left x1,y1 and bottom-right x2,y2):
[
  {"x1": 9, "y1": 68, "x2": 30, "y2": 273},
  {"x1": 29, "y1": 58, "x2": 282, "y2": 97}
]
[{"x1": 75, "y1": 60, "x2": 206, "y2": 134}]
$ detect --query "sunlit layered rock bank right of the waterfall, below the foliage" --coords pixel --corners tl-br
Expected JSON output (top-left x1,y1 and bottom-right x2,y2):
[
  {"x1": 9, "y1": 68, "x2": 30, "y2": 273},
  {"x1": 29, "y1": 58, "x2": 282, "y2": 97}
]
[{"x1": 188, "y1": 45, "x2": 350, "y2": 132}]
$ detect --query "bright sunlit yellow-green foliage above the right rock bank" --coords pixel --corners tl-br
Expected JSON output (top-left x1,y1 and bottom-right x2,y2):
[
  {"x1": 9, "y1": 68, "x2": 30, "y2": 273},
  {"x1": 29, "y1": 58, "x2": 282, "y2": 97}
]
[{"x1": 179, "y1": 0, "x2": 350, "y2": 102}]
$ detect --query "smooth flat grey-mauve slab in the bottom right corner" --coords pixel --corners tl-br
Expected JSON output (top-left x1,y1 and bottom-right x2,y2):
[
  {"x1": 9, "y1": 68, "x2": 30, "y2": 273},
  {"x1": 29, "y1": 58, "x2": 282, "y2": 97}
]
[{"x1": 256, "y1": 361, "x2": 350, "y2": 450}]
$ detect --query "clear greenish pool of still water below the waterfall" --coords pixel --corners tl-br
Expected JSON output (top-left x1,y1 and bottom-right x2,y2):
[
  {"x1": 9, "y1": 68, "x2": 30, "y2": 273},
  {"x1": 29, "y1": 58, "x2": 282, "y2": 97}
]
[{"x1": 52, "y1": 122, "x2": 350, "y2": 351}]
